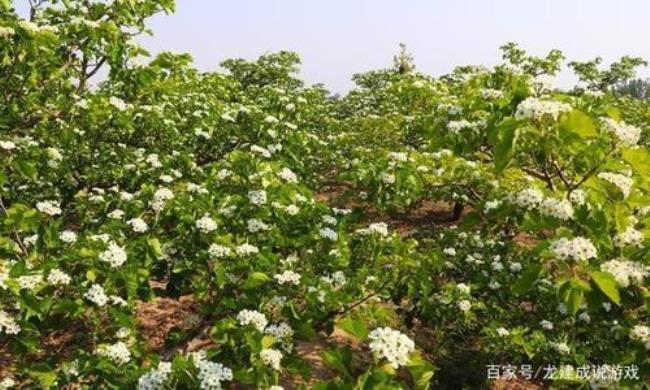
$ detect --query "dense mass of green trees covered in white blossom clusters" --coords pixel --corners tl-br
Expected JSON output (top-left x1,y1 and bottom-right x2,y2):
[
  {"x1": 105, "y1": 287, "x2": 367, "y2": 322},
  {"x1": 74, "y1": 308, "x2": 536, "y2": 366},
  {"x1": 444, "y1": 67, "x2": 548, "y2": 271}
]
[{"x1": 0, "y1": 0, "x2": 650, "y2": 389}]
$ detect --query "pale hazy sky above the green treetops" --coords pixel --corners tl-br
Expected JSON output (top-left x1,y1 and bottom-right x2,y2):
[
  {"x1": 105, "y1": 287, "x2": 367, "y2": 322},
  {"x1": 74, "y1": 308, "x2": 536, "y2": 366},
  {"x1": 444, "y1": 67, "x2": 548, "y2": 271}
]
[{"x1": 15, "y1": 0, "x2": 650, "y2": 93}]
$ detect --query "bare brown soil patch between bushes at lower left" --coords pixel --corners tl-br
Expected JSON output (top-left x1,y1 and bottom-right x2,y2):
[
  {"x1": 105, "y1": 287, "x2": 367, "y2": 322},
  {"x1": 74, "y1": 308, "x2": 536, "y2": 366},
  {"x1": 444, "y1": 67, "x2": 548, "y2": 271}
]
[{"x1": 136, "y1": 295, "x2": 200, "y2": 352}]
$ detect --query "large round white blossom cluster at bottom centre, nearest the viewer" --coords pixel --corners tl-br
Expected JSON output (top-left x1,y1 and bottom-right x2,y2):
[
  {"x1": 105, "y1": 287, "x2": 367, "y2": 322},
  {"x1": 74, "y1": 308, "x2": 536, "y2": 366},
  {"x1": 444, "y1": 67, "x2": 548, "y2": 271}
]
[{"x1": 368, "y1": 327, "x2": 415, "y2": 368}]
